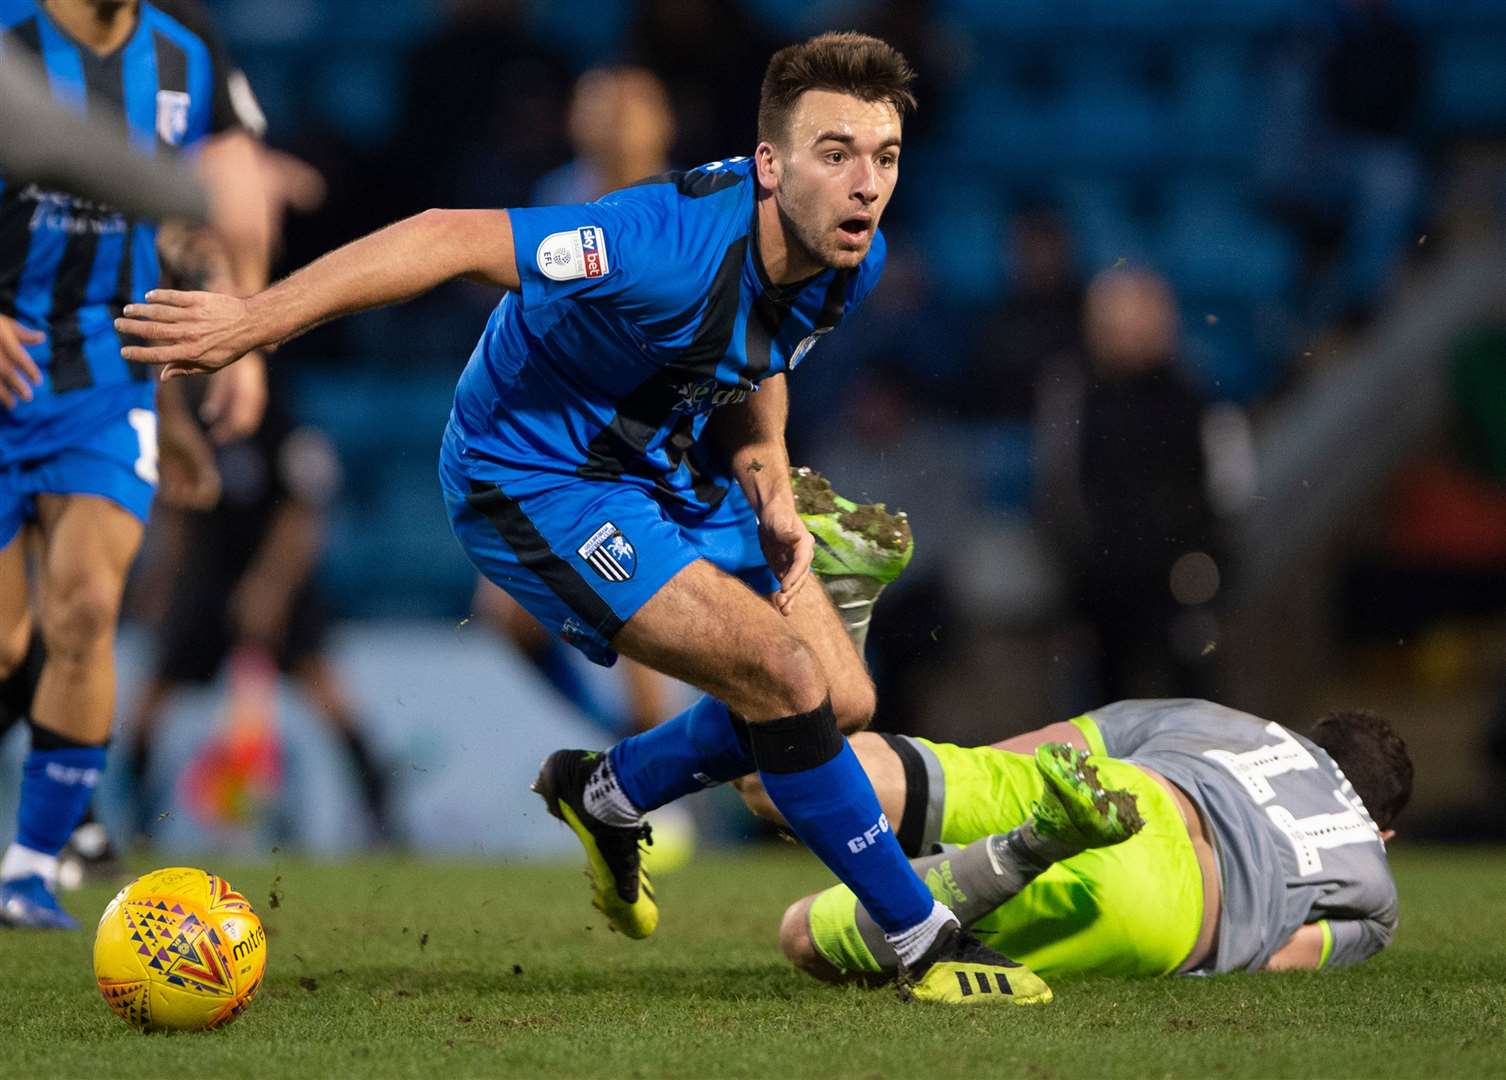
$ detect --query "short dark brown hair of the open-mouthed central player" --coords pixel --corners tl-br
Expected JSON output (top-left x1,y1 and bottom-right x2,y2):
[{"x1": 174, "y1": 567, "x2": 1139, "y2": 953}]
[{"x1": 758, "y1": 30, "x2": 916, "y2": 142}]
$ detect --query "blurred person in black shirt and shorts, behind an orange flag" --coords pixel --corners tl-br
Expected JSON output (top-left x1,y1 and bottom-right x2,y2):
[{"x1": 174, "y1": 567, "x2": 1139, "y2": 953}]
[{"x1": 127, "y1": 381, "x2": 387, "y2": 836}]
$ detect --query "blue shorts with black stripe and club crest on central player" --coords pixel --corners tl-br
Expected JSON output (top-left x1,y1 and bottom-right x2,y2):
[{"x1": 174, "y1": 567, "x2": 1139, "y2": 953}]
[{"x1": 440, "y1": 430, "x2": 779, "y2": 666}]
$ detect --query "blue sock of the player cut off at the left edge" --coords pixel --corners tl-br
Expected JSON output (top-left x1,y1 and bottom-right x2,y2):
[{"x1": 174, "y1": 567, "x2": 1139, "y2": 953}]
[{"x1": 0, "y1": 725, "x2": 105, "y2": 884}]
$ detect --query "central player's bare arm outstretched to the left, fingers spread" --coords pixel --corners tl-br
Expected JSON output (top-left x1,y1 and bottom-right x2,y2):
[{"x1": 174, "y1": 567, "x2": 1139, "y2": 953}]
[{"x1": 114, "y1": 209, "x2": 521, "y2": 378}]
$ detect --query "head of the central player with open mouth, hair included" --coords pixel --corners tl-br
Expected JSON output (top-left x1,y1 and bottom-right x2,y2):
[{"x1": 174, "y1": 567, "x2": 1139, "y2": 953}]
[{"x1": 758, "y1": 32, "x2": 916, "y2": 268}]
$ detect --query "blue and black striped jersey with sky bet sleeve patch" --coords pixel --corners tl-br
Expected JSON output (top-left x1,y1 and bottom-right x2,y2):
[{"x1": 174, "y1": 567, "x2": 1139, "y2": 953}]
[{"x1": 450, "y1": 158, "x2": 884, "y2": 509}]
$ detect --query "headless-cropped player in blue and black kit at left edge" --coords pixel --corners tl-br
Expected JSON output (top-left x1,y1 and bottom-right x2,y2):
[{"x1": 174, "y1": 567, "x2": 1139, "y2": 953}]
[{"x1": 0, "y1": 0, "x2": 268, "y2": 928}]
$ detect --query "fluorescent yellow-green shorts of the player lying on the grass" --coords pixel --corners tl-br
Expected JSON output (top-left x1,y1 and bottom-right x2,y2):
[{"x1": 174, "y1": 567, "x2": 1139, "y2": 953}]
[{"x1": 810, "y1": 716, "x2": 1203, "y2": 978}]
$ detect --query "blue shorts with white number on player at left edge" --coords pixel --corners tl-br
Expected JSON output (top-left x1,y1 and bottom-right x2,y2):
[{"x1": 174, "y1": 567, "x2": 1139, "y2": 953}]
[{"x1": 0, "y1": 408, "x2": 157, "y2": 547}]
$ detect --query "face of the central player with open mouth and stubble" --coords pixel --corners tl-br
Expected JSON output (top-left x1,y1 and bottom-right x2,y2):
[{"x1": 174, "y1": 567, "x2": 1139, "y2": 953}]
[{"x1": 774, "y1": 90, "x2": 899, "y2": 268}]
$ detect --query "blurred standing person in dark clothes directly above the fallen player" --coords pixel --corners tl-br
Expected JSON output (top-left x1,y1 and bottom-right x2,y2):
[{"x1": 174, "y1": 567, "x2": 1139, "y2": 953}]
[{"x1": 1038, "y1": 270, "x2": 1220, "y2": 702}]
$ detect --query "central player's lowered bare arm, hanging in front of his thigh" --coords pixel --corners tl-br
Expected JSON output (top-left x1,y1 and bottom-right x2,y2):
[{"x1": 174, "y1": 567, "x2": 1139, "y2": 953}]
[{"x1": 712, "y1": 375, "x2": 815, "y2": 612}]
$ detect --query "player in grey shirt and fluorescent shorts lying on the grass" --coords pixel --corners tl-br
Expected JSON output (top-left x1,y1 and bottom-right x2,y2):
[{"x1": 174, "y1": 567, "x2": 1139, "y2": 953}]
[{"x1": 739, "y1": 700, "x2": 1413, "y2": 993}]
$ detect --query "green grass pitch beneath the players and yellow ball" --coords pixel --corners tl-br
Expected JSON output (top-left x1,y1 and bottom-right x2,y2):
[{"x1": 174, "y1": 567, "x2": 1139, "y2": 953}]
[{"x1": 0, "y1": 848, "x2": 1506, "y2": 1080}]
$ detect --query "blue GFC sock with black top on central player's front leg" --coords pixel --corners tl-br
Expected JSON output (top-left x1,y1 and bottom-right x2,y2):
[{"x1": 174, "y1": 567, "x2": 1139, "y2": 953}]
[{"x1": 748, "y1": 699, "x2": 935, "y2": 934}]
